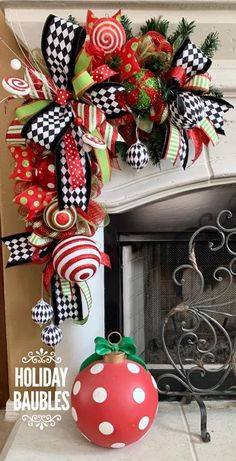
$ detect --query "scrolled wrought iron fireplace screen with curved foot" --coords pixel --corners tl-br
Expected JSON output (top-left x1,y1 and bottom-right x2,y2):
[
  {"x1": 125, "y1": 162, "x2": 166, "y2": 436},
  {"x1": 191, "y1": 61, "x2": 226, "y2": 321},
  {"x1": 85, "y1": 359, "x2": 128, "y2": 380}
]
[{"x1": 157, "y1": 210, "x2": 236, "y2": 442}]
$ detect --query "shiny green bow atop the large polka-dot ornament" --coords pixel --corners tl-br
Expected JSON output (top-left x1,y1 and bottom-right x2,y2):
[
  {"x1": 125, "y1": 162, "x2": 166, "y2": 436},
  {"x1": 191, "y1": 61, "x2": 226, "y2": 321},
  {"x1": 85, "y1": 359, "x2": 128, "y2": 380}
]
[{"x1": 80, "y1": 336, "x2": 147, "y2": 371}]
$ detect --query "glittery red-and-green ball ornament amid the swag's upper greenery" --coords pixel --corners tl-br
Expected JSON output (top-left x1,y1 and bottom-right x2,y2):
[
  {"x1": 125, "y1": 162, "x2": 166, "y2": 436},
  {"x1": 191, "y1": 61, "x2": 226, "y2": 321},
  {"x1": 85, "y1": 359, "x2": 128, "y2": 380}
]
[{"x1": 124, "y1": 69, "x2": 160, "y2": 110}]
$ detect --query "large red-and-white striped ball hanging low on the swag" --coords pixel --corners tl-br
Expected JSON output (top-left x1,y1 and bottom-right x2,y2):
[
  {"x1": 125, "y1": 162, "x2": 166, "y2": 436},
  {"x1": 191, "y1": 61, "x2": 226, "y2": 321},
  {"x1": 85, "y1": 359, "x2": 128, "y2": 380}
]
[{"x1": 52, "y1": 236, "x2": 101, "y2": 282}]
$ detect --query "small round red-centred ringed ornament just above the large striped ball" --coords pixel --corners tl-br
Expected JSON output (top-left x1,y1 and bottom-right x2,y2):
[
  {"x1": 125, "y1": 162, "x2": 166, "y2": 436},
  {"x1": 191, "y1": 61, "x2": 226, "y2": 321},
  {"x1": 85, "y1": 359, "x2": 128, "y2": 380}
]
[{"x1": 43, "y1": 200, "x2": 77, "y2": 232}]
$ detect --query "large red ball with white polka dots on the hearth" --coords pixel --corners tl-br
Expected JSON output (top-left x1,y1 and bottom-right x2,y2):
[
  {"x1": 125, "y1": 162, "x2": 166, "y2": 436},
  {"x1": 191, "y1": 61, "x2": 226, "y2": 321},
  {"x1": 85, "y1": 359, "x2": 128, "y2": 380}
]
[{"x1": 71, "y1": 352, "x2": 158, "y2": 448}]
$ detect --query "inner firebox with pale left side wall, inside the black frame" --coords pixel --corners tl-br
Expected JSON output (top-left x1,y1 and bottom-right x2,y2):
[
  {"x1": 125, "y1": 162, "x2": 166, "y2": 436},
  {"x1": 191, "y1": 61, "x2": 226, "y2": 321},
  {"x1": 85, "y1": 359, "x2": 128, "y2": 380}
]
[{"x1": 121, "y1": 235, "x2": 236, "y2": 369}]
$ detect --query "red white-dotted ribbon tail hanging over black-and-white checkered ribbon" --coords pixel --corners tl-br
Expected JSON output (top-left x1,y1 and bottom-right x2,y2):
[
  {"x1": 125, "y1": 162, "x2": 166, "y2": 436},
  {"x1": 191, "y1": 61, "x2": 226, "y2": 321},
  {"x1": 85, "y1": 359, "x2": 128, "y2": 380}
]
[{"x1": 63, "y1": 130, "x2": 85, "y2": 189}]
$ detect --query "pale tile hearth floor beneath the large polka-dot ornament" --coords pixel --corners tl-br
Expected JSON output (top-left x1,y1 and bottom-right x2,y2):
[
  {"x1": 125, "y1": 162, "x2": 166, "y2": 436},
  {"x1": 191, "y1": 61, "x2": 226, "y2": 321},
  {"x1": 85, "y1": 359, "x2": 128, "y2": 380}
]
[{"x1": 0, "y1": 401, "x2": 236, "y2": 461}]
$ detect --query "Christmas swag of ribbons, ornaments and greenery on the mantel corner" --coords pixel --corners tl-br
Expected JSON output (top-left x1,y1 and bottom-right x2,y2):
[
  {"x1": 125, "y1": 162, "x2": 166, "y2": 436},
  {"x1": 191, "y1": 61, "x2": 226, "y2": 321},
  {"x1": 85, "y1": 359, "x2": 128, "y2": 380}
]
[{"x1": 2, "y1": 10, "x2": 232, "y2": 346}]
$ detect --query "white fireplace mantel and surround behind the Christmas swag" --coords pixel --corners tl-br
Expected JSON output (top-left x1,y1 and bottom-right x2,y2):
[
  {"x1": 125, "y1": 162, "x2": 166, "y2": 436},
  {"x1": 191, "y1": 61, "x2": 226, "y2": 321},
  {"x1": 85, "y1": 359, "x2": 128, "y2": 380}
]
[{"x1": 0, "y1": 0, "x2": 236, "y2": 387}]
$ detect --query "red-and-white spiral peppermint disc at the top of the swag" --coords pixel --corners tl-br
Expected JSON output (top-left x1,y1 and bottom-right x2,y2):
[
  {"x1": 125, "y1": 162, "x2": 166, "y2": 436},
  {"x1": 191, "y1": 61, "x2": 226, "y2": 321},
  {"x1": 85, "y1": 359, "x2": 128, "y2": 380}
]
[{"x1": 90, "y1": 18, "x2": 125, "y2": 54}]
